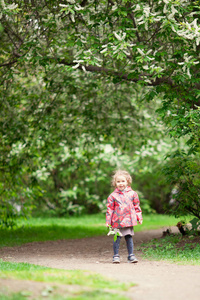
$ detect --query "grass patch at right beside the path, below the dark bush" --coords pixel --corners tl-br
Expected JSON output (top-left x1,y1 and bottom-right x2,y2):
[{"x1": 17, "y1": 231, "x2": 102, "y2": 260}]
[{"x1": 141, "y1": 234, "x2": 200, "y2": 265}]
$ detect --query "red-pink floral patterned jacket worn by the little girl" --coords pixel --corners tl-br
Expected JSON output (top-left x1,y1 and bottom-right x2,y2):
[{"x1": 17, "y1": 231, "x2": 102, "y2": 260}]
[{"x1": 106, "y1": 186, "x2": 142, "y2": 228}]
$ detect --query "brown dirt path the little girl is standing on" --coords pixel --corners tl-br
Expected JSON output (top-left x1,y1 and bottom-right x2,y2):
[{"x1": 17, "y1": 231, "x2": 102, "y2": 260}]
[{"x1": 0, "y1": 228, "x2": 200, "y2": 300}]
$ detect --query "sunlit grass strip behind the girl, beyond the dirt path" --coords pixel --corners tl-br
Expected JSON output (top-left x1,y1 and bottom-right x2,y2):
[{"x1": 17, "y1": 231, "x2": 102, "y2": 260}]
[{"x1": 0, "y1": 214, "x2": 181, "y2": 247}]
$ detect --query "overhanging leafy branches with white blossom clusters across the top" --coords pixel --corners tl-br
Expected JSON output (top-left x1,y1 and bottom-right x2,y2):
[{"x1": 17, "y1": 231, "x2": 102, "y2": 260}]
[{"x1": 0, "y1": 0, "x2": 200, "y2": 141}]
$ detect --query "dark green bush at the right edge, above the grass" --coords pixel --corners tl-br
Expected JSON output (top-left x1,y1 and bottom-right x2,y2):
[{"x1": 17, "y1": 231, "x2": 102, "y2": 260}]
[{"x1": 163, "y1": 151, "x2": 200, "y2": 219}]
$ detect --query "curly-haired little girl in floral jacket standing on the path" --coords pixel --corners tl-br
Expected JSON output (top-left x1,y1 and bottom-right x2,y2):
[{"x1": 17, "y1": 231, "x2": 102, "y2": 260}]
[{"x1": 106, "y1": 170, "x2": 142, "y2": 263}]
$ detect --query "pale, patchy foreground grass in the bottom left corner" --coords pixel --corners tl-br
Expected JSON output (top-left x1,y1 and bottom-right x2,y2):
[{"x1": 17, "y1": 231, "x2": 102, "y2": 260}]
[{"x1": 0, "y1": 260, "x2": 133, "y2": 300}]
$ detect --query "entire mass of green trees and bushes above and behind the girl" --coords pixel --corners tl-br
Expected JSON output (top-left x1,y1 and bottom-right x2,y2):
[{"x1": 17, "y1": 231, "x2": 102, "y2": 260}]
[{"x1": 0, "y1": 0, "x2": 200, "y2": 226}]
